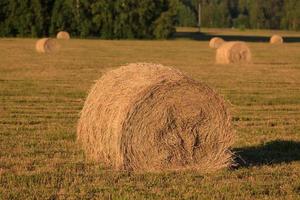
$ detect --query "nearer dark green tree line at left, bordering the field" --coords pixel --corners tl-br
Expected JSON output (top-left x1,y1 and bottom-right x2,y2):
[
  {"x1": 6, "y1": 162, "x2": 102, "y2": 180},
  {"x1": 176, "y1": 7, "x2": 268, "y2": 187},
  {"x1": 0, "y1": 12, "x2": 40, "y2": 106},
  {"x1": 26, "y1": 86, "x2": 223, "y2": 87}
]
[{"x1": 0, "y1": 0, "x2": 178, "y2": 39}]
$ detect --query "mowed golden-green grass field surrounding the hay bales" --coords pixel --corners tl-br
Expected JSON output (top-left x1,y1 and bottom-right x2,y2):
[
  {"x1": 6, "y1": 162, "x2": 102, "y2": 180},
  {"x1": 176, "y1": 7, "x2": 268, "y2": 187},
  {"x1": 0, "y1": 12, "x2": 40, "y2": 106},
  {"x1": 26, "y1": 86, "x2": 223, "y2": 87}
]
[{"x1": 0, "y1": 29, "x2": 300, "y2": 199}]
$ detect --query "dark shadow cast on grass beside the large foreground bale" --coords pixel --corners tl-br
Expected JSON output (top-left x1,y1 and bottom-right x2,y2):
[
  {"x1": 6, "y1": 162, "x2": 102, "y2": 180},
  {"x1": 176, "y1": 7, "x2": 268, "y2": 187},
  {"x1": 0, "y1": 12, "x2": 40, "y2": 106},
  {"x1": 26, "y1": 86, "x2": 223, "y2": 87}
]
[{"x1": 234, "y1": 140, "x2": 300, "y2": 168}]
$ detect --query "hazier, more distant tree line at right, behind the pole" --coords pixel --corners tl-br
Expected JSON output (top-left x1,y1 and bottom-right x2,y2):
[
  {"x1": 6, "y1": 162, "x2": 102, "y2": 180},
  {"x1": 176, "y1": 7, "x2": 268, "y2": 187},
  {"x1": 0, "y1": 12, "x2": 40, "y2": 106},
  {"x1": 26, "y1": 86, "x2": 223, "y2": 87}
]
[{"x1": 178, "y1": 0, "x2": 300, "y2": 30}]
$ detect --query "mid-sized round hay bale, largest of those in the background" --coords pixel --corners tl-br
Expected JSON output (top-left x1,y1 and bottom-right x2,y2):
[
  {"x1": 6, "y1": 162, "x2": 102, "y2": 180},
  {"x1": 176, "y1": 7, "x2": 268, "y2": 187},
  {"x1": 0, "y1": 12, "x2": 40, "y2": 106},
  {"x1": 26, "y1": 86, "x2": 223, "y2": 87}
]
[{"x1": 216, "y1": 42, "x2": 252, "y2": 64}]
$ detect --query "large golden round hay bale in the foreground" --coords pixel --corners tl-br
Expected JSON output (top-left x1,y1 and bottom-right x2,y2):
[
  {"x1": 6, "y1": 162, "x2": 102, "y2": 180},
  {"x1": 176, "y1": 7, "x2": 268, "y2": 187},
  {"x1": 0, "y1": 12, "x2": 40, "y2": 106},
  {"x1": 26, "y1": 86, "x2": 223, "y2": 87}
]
[{"x1": 77, "y1": 63, "x2": 233, "y2": 172}]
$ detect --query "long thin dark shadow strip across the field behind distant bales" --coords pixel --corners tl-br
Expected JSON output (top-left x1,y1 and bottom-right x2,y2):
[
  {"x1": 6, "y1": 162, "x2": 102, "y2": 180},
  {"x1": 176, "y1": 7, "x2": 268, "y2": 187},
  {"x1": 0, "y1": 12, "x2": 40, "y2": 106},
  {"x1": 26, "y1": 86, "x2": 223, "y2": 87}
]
[{"x1": 174, "y1": 32, "x2": 300, "y2": 43}]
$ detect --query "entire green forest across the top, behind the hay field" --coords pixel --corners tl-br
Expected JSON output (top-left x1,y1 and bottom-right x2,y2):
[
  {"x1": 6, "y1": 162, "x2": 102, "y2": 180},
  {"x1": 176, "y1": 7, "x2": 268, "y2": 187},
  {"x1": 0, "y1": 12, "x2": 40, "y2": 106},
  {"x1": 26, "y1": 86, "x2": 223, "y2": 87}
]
[{"x1": 0, "y1": 0, "x2": 300, "y2": 39}]
